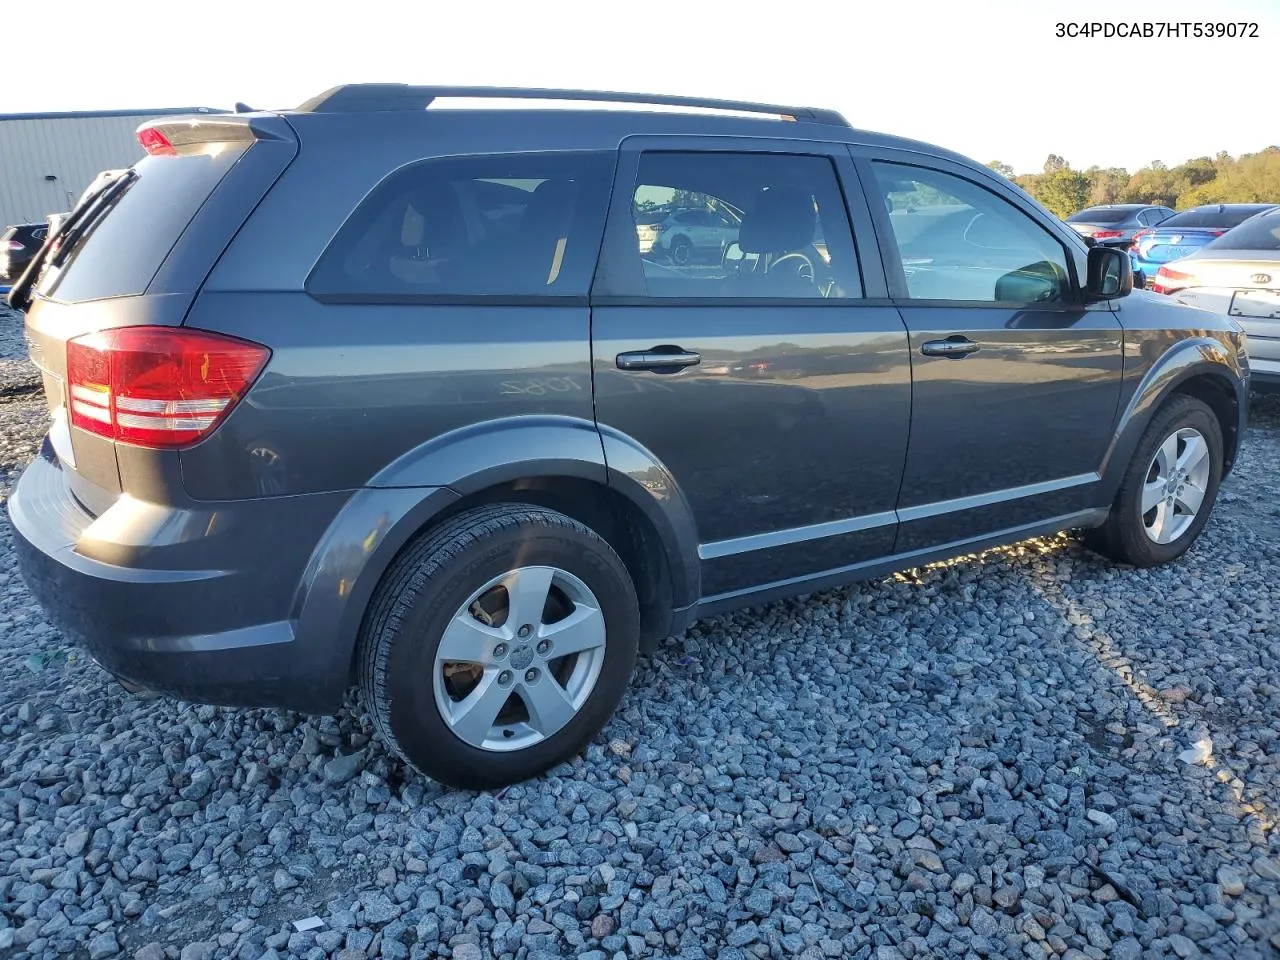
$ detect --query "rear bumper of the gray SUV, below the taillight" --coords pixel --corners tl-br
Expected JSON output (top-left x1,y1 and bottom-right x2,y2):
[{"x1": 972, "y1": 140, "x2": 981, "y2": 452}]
[{"x1": 9, "y1": 440, "x2": 351, "y2": 713}]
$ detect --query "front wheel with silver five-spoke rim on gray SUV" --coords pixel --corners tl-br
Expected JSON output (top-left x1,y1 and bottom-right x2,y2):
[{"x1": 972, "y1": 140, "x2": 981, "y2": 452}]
[{"x1": 1085, "y1": 396, "x2": 1222, "y2": 567}]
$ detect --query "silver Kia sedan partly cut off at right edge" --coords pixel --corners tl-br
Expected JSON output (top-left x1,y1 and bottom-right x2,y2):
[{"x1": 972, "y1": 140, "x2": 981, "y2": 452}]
[{"x1": 1151, "y1": 206, "x2": 1280, "y2": 390}]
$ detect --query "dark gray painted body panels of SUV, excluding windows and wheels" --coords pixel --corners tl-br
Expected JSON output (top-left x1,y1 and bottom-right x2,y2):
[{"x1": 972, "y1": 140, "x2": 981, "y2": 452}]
[{"x1": 9, "y1": 97, "x2": 1247, "y2": 710}]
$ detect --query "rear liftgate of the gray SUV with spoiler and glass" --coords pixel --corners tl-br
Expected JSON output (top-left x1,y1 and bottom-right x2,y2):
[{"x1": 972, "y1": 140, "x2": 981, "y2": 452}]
[{"x1": 9, "y1": 114, "x2": 297, "y2": 516}]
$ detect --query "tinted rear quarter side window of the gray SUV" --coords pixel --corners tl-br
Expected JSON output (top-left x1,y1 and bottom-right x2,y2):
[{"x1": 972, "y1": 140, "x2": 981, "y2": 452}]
[{"x1": 307, "y1": 151, "x2": 613, "y2": 302}]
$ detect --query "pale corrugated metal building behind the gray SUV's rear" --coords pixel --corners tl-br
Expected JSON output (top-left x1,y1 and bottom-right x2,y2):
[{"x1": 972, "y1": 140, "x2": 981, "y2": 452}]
[{"x1": 0, "y1": 106, "x2": 220, "y2": 230}]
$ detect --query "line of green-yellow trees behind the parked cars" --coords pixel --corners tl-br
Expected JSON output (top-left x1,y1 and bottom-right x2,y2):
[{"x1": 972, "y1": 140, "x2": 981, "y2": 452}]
[{"x1": 987, "y1": 146, "x2": 1280, "y2": 216}]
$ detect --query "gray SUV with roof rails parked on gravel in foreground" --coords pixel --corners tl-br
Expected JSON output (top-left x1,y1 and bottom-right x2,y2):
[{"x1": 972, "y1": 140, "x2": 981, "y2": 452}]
[{"x1": 9, "y1": 84, "x2": 1248, "y2": 788}]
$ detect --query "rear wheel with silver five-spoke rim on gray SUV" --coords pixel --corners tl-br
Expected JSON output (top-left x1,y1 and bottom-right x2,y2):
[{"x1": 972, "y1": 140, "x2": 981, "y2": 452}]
[{"x1": 358, "y1": 503, "x2": 640, "y2": 790}]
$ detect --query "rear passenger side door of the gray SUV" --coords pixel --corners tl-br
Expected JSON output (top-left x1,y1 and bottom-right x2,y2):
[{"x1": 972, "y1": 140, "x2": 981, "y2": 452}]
[{"x1": 591, "y1": 137, "x2": 910, "y2": 598}]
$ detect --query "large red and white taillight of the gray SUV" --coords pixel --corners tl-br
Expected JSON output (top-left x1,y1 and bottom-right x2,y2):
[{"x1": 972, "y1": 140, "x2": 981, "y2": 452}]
[{"x1": 67, "y1": 326, "x2": 271, "y2": 448}]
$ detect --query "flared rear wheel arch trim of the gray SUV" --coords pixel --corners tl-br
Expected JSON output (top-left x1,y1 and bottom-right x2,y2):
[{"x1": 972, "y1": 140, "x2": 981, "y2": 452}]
[{"x1": 293, "y1": 417, "x2": 700, "y2": 701}]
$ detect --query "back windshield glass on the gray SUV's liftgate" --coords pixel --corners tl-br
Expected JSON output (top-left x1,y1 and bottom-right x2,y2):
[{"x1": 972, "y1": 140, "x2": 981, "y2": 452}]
[{"x1": 40, "y1": 143, "x2": 247, "y2": 302}]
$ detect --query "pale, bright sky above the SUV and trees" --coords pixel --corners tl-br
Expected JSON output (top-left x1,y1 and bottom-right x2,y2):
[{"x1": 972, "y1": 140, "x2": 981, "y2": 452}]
[{"x1": 0, "y1": 0, "x2": 1280, "y2": 173}]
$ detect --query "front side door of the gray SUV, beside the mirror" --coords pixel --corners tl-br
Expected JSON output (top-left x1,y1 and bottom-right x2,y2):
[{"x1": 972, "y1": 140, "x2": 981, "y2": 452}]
[{"x1": 859, "y1": 152, "x2": 1123, "y2": 553}]
